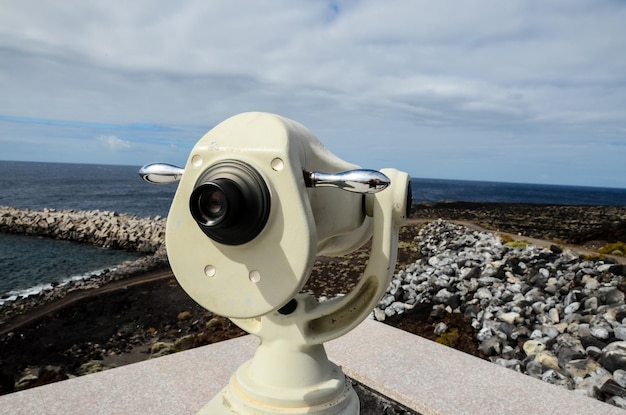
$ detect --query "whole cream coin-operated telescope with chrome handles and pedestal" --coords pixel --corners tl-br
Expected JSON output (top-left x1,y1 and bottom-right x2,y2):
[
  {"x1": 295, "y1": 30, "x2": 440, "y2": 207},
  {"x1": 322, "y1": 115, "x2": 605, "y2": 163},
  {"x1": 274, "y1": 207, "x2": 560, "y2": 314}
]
[{"x1": 140, "y1": 113, "x2": 411, "y2": 415}]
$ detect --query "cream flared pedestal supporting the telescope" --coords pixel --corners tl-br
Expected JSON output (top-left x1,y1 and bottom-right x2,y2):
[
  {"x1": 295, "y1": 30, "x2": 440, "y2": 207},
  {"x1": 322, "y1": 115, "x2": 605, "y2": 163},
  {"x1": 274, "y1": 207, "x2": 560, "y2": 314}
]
[{"x1": 199, "y1": 302, "x2": 360, "y2": 415}]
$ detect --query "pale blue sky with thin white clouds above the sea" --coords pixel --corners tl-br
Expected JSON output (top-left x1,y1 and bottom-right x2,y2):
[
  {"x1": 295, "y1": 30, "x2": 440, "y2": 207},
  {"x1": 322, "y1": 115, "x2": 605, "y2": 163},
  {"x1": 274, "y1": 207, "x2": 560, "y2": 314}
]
[{"x1": 0, "y1": 0, "x2": 626, "y2": 188}]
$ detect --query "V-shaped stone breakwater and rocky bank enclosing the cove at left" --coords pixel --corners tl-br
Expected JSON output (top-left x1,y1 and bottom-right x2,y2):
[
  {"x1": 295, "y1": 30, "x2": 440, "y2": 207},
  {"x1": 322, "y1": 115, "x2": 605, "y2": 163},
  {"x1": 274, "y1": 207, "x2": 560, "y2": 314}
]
[{"x1": 0, "y1": 206, "x2": 167, "y2": 326}]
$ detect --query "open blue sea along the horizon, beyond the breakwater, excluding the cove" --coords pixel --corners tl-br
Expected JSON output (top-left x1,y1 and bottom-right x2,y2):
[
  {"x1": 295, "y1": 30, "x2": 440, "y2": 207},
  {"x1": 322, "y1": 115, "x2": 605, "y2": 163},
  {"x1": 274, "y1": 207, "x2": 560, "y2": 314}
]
[{"x1": 0, "y1": 161, "x2": 626, "y2": 217}]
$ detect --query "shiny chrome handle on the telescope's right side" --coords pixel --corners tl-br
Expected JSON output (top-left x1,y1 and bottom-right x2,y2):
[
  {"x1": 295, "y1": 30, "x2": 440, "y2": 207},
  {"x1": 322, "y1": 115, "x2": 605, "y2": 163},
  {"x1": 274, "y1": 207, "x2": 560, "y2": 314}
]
[{"x1": 302, "y1": 169, "x2": 391, "y2": 193}]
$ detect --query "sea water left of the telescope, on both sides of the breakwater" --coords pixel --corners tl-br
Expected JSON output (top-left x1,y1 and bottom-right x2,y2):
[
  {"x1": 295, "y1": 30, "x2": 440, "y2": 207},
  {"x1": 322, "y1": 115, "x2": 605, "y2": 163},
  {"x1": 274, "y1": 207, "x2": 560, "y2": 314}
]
[{"x1": 0, "y1": 161, "x2": 176, "y2": 304}]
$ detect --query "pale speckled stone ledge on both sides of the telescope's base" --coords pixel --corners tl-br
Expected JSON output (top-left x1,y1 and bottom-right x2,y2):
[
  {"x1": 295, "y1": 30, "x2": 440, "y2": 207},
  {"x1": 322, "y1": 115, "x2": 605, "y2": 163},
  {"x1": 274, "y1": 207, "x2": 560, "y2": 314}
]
[{"x1": 0, "y1": 320, "x2": 626, "y2": 415}]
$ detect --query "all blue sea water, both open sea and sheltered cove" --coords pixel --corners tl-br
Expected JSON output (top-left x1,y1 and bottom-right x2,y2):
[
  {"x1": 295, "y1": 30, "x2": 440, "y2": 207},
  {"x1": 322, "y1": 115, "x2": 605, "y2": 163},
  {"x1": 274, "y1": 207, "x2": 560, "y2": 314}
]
[{"x1": 0, "y1": 161, "x2": 626, "y2": 304}]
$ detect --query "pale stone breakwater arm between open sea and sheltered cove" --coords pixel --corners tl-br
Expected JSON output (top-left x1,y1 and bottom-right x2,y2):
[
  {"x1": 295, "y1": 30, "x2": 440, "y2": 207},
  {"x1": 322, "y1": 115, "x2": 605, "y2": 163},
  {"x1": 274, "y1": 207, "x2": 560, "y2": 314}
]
[{"x1": 0, "y1": 206, "x2": 165, "y2": 253}]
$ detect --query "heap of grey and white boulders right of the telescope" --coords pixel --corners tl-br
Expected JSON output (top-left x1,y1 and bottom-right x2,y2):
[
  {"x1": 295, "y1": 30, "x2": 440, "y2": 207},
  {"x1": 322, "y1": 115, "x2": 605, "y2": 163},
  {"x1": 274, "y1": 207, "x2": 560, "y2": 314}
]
[{"x1": 372, "y1": 220, "x2": 626, "y2": 408}]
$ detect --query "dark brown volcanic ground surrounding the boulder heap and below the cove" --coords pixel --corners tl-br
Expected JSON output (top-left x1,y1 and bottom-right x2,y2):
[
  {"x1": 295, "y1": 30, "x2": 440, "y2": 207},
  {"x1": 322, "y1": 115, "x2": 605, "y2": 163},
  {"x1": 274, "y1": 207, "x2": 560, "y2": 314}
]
[{"x1": 0, "y1": 203, "x2": 626, "y2": 404}]
